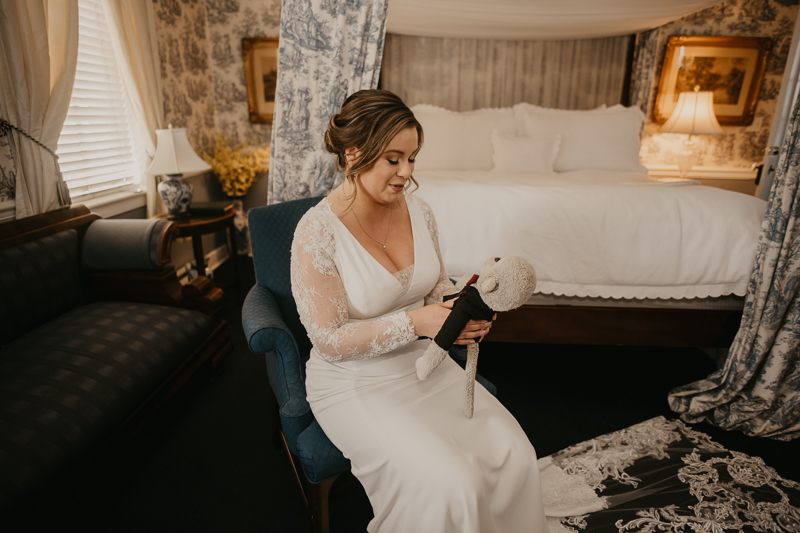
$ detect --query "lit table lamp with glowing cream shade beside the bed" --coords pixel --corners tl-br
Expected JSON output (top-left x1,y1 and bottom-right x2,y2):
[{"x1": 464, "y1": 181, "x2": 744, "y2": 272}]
[{"x1": 661, "y1": 85, "x2": 722, "y2": 178}]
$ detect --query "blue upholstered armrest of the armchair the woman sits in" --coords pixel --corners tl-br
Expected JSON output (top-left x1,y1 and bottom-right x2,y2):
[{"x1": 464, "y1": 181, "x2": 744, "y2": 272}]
[{"x1": 242, "y1": 285, "x2": 314, "y2": 455}]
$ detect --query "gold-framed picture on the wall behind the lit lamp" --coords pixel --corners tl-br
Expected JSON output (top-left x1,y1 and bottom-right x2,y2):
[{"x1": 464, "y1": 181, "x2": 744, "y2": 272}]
[{"x1": 653, "y1": 35, "x2": 772, "y2": 126}]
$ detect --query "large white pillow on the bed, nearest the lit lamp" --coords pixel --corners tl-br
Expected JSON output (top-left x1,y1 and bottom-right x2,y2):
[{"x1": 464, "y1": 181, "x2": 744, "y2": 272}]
[{"x1": 515, "y1": 106, "x2": 647, "y2": 172}]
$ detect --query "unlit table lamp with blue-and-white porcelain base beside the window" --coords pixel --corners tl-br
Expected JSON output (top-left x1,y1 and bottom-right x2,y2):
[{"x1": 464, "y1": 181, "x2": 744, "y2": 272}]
[{"x1": 147, "y1": 124, "x2": 211, "y2": 220}]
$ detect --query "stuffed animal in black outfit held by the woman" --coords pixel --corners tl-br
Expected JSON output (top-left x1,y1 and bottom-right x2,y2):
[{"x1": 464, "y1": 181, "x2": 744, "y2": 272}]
[{"x1": 416, "y1": 257, "x2": 536, "y2": 418}]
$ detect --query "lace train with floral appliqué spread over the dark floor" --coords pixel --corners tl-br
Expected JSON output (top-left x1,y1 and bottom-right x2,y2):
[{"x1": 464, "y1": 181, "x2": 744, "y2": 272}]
[{"x1": 540, "y1": 417, "x2": 800, "y2": 533}]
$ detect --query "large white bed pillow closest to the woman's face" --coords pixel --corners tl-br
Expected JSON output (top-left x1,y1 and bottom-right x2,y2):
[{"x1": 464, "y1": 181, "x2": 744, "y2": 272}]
[{"x1": 411, "y1": 104, "x2": 517, "y2": 170}]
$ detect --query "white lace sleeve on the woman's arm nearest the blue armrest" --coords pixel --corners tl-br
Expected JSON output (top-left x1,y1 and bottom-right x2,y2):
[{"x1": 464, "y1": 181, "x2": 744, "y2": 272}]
[{"x1": 291, "y1": 208, "x2": 417, "y2": 362}]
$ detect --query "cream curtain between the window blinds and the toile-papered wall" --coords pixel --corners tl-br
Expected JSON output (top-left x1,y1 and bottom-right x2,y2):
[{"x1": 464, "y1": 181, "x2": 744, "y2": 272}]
[{"x1": 103, "y1": 0, "x2": 165, "y2": 216}]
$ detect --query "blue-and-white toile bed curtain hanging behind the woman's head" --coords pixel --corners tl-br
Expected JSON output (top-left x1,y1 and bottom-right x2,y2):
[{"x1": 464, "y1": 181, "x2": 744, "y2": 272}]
[{"x1": 267, "y1": 0, "x2": 388, "y2": 204}]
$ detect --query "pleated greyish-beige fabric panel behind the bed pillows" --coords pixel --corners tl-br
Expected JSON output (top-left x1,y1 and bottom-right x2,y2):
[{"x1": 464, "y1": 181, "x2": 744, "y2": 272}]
[{"x1": 381, "y1": 34, "x2": 631, "y2": 111}]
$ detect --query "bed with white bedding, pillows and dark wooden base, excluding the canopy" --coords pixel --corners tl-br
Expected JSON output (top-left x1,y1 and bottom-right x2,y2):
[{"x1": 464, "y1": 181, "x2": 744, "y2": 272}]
[{"x1": 413, "y1": 104, "x2": 766, "y2": 347}]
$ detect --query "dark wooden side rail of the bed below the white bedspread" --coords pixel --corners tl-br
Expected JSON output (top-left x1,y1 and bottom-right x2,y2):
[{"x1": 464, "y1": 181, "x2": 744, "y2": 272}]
[{"x1": 494, "y1": 305, "x2": 742, "y2": 348}]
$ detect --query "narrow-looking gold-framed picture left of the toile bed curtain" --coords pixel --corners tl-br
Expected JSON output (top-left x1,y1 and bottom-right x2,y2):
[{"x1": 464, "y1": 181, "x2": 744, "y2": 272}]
[{"x1": 242, "y1": 37, "x2": 278, "y2": 124}]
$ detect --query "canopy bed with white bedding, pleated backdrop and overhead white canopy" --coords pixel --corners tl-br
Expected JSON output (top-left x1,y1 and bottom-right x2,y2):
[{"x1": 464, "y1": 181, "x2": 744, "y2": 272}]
[{"x1": 381, "y1": 0, "x2": 766, "y2": 347}]
